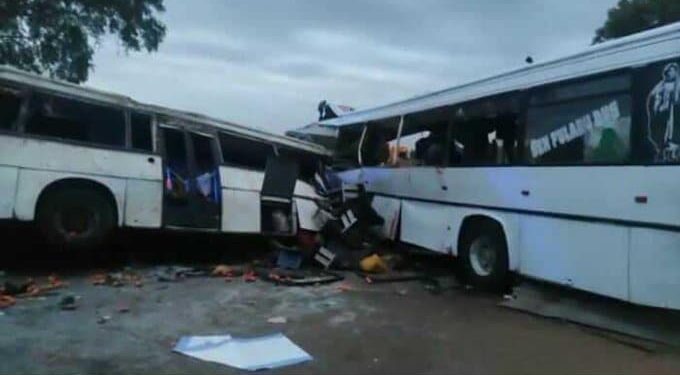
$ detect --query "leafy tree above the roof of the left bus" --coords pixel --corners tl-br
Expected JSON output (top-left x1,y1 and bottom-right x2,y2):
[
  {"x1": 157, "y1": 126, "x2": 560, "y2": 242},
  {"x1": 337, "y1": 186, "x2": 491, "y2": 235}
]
[{"x1": 0, "y1": 0, "x2": 165, "y2": 83}]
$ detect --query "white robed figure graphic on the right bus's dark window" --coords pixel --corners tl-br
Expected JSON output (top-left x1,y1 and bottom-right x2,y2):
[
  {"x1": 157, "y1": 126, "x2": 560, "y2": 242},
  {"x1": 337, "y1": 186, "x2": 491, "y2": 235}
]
[{"x1": 647, "y1": 63, "x2": 680, "y2": 161}]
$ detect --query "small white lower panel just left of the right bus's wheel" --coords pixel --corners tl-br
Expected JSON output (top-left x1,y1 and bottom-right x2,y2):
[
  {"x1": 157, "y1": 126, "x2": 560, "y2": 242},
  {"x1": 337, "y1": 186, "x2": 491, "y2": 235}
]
[{"x1": 401, "y1": 200, "x2": 456, "y2": 254}]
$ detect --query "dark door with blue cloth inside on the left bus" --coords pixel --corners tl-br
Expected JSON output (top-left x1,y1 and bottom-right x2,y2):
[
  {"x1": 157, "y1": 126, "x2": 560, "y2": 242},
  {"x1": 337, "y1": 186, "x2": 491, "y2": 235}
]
[{"x1": 160, "y1": 126, "x2": 221, "y2": 230}]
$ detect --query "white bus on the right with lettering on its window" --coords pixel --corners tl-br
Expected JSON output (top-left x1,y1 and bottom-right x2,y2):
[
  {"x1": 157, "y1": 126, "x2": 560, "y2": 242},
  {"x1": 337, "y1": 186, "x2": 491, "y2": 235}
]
[{"x1": 312, "y1": 24, "x2": 680, "y2": 309}]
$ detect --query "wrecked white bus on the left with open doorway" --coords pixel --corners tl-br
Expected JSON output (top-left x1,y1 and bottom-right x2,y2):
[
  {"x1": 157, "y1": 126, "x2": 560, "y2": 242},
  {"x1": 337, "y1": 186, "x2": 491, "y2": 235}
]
[{"x1": 0, "y1": 67, "x2": 328, "y2": 247}]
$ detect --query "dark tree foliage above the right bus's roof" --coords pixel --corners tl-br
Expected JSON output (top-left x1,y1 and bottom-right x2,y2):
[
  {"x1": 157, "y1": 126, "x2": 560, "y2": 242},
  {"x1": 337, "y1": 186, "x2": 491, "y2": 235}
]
[{"x1": 593, "y1": 0, "x2": 680, "y2": 44}]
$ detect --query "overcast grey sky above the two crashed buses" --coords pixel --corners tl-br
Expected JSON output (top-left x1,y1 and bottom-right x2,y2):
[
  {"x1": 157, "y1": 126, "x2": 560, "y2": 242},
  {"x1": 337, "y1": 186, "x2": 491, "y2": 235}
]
[{"x1": 87, "y1": 0, "x2": 616, "y2": 133}]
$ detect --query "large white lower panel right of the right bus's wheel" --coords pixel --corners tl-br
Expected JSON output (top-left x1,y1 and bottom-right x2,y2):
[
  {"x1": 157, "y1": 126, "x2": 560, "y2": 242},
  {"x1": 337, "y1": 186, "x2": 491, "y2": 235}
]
[{"x1": 520, "y1": 215, "x2": 629, "y2": 300}]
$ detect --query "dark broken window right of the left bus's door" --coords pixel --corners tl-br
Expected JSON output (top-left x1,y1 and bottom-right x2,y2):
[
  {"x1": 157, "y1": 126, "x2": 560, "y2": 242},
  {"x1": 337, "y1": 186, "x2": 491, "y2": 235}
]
[{"x1": 219, "y1": 132, "x2": 274, "y2": 171}]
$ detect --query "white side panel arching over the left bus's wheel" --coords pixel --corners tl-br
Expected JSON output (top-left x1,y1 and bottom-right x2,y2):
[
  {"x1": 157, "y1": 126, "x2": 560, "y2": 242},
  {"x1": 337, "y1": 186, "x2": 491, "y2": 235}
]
[{"x1": 15, "y1": 169, "x2": 125, "y2": 225}]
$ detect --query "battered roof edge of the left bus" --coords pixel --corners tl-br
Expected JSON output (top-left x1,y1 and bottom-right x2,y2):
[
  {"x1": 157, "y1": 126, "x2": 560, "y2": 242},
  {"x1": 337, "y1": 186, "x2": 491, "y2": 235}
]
[{"x1": 0, "y1": 65, "x2": 330, "y2": 156}]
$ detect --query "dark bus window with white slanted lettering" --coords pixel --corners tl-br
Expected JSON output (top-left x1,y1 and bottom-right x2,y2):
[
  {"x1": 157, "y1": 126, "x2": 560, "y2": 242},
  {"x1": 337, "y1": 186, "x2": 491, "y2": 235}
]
[{"x1": 525, "y1": 75, "x2": 631, "y2": 164}]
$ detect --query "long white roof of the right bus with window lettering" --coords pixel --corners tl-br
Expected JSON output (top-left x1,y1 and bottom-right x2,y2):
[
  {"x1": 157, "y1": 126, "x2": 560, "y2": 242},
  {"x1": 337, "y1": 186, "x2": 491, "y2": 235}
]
[{"x1": 318, "y1": 22, "x2": 680, "y2": 126}]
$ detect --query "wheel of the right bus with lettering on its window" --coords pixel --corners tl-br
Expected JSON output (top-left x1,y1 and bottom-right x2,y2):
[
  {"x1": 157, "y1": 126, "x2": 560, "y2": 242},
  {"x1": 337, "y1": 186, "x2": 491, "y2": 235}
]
[{"x1": 459, "y1": 220, "x2": 509, "y2": 291}]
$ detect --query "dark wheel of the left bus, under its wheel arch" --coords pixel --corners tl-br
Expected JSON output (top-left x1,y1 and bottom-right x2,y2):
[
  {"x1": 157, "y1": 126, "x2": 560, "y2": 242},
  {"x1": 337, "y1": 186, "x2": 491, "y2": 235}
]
[{"x1": 37, "y1": 187, "x2": 116, "y2": 248}]
